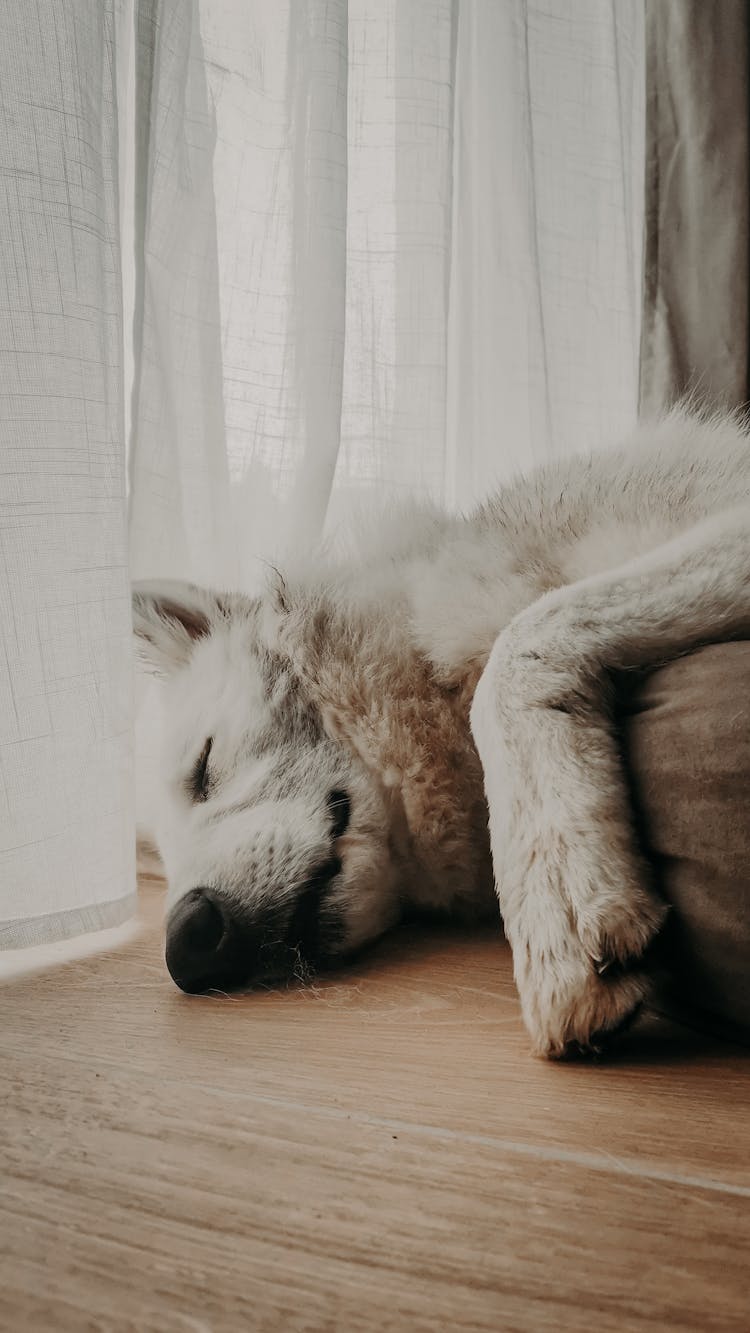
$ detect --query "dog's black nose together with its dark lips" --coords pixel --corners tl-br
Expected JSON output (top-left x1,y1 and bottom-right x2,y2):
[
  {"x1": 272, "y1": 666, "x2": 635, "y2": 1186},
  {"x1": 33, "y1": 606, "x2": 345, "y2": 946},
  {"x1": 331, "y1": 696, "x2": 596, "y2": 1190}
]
[{"x1": 165, "y1": 857, "x2": 341, "y2": 994}]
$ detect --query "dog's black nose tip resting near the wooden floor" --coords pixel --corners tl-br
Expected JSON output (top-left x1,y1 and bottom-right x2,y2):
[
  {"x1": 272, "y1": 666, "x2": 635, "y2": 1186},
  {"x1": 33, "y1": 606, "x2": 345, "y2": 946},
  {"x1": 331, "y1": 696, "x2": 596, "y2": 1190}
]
[{"x1": 167, "y1": 889, "x2": 245, "y2": 994}]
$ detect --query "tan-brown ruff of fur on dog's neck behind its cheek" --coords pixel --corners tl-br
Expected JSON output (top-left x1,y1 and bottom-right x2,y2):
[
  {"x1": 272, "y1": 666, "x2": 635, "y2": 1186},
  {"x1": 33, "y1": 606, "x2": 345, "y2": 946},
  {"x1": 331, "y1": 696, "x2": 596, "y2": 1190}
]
[{"x1": 266, "y1": 559, "x2": 497, "y2": 917}]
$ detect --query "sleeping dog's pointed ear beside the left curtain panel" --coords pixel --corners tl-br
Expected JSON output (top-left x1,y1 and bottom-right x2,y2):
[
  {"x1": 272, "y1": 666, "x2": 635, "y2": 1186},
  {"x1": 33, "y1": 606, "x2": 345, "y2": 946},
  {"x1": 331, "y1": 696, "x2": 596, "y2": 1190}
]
[{"x1": 133, "y1": 579, "x2": 226, "y2": 676}]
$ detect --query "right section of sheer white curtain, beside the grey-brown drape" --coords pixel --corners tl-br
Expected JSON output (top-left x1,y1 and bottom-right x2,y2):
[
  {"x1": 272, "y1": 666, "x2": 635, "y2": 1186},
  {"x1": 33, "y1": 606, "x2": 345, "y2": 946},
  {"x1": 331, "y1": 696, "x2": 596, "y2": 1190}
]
[{"x1": 448, "y1": 0, "x2": 645, "y2": 505}]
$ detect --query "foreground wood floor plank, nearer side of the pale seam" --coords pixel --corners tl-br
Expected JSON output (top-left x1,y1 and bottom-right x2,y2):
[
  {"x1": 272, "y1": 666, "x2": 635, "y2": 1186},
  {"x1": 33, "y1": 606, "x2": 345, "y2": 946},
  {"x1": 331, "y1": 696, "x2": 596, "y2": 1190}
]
[{"x1": 0, "y1": 1058, "x2": 750, "y2": 1330}]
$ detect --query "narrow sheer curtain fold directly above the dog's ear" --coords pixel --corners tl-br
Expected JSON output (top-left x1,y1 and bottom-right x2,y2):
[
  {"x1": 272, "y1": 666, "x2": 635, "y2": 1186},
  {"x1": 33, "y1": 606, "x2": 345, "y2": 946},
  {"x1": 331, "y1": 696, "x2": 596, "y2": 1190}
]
[{"x1": 129, "y1": 0, "x2": 232, "y2": 580}]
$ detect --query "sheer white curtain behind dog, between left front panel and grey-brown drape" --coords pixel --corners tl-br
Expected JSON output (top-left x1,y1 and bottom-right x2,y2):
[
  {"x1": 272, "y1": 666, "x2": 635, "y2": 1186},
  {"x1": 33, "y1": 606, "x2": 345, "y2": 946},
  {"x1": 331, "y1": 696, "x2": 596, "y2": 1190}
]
[{"x1": 131, "y1": 0, "x2": 643, "y2": 583}]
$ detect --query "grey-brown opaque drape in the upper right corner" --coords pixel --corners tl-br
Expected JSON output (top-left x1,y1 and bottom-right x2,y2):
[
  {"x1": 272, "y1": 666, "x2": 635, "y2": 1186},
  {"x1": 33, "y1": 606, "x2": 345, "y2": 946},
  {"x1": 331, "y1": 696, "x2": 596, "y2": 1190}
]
[{"x1": 641, "y1": 0, "x2": 750, "y2": 413}]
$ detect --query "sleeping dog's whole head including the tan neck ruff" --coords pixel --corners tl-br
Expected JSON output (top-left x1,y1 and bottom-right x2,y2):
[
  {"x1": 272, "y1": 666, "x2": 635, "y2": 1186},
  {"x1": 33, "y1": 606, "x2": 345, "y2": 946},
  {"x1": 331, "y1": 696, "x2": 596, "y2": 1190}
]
[{"x1": 133, "y1": 583, "x2": 489, "y2": 990}]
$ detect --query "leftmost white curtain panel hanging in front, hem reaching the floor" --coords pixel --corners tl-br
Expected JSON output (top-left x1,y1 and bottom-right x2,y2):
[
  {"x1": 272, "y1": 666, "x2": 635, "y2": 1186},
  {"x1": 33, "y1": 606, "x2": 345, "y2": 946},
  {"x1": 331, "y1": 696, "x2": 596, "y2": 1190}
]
[{"x1": 0, "y1": 0, "x2": 135, "y2": 948}]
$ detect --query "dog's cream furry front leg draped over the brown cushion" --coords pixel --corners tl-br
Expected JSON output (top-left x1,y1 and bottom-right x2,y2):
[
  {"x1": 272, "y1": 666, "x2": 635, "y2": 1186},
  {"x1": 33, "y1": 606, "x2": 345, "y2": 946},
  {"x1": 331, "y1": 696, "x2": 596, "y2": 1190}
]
[{"x1": 472, "y1": 507, "x2": 750, "y2": 1056}]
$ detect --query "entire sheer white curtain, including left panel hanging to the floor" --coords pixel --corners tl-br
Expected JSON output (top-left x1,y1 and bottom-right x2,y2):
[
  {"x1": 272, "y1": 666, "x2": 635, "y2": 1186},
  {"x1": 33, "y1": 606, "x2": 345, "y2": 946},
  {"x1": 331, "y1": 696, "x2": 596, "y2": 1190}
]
[{"x1": 0, "y1": 0, "x2": 643, "y2": 942}]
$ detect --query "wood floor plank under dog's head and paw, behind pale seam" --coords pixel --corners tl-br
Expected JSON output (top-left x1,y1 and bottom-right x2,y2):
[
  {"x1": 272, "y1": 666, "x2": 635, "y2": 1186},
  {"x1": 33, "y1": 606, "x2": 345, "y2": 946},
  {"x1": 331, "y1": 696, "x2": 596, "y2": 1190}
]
[{"x1": 0, "y1": 893, "x2": 750, "y2": 1185}]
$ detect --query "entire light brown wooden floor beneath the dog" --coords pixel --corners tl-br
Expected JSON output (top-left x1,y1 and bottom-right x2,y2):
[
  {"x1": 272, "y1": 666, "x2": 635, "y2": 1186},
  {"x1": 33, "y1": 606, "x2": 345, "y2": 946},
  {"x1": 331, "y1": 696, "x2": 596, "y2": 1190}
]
[{"x1": 0, "y1": 885, "x2": 750, "y2": 1333}]
